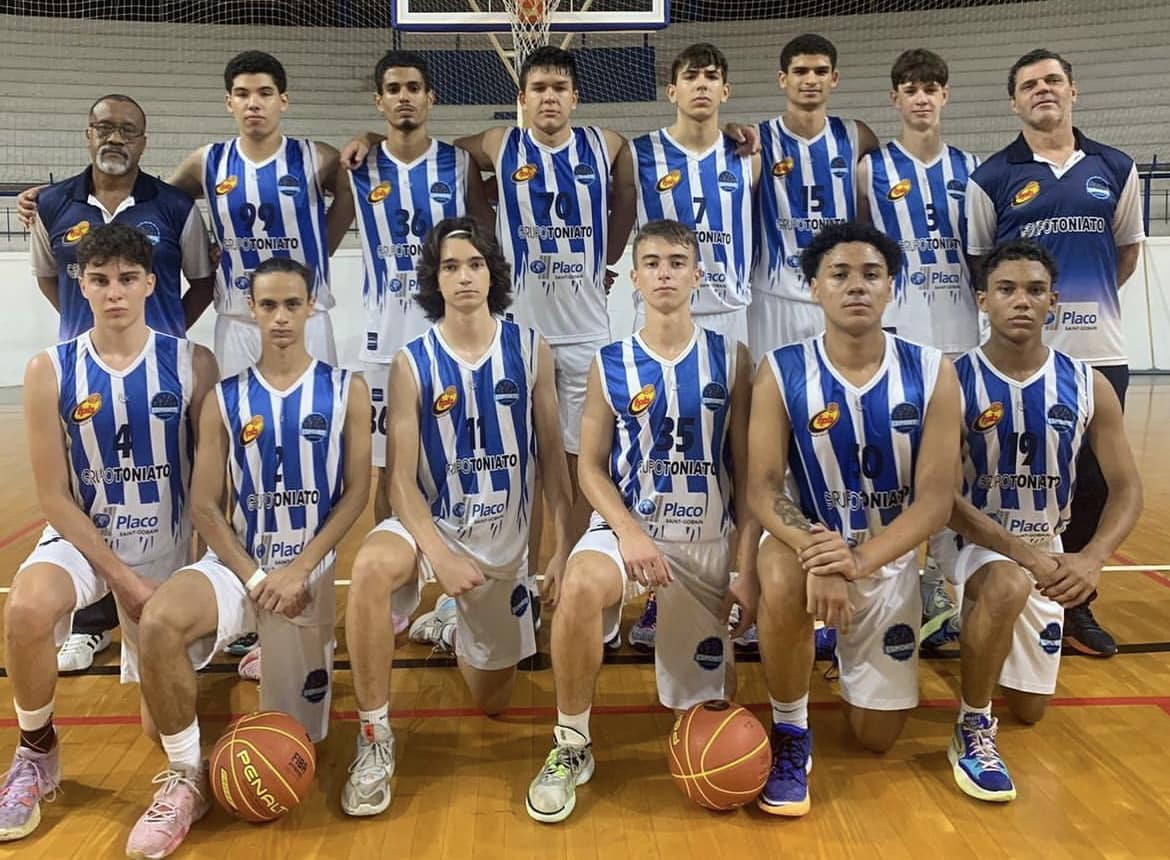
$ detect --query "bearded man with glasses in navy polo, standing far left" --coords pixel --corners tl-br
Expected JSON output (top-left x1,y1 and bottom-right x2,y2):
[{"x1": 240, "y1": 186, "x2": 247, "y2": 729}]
[{"x1": 30, "y1": 95, "x2": 214, "y2": 340}]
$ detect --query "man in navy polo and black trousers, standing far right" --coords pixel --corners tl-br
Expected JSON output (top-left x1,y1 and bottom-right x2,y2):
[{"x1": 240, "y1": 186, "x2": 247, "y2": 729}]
[{"x1": 968, "y1": 48, "x2": 1145, "y2": 658}]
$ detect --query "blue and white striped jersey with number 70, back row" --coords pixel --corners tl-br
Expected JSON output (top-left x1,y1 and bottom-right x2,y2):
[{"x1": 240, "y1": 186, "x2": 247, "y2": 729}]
[{"x1": 496, "y1": 126, "x2": 610, "y2": 345}]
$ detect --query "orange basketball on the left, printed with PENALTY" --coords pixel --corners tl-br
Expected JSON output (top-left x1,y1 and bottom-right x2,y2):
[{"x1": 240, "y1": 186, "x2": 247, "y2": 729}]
[{"x1": 211, "y1": 710, "x2": 317, "y2": 823}]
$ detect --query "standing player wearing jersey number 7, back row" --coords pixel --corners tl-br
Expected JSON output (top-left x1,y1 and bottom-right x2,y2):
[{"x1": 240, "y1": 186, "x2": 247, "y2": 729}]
[{"x1": 615, "y1": 42, "x2": 759, "y2": 343}]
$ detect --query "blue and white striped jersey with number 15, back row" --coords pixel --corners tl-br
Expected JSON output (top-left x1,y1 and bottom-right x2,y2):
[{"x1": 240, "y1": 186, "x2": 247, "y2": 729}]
[{"x1": 752, "y1": 117, "x2": 858, "y2": 302}]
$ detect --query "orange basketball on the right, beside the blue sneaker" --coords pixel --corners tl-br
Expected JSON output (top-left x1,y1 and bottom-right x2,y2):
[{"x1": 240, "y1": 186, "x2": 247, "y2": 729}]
[{"x1": 667, "y1": 700, "x2": 772, "y2": 810}]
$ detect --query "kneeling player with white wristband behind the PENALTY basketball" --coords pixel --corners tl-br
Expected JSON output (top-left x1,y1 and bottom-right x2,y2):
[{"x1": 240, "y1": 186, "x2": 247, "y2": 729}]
[{"x1": 126, "y1": 257, "x2": 370, "y2": 858}]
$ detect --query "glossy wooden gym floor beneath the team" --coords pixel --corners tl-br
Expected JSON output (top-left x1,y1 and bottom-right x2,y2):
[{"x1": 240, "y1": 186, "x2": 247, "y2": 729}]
[{"x1": 0, "y1": 378, "x2": 1170, "y2": 860}]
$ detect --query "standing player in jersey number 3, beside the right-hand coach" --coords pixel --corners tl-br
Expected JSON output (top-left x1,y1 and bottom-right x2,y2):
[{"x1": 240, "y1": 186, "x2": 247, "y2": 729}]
[{"x1": 858, "y1": 48, "x2": 979, "y2": 645}]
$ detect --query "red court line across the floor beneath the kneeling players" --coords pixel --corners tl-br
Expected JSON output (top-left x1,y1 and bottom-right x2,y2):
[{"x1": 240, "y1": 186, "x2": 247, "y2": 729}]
[{"x1": 0, "y1": 696, "x2": 1170, "y2": 729}]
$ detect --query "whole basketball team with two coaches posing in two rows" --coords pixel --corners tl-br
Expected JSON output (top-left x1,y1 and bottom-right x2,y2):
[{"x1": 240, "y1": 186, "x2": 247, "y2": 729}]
[{"x1": 0, "y1": 34, "x2": 1144, "y2": 858}]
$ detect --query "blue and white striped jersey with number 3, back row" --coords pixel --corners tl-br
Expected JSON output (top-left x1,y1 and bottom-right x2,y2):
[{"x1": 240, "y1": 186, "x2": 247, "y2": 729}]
[{"x1": 861, "y1": 140, "x2": 979, "y2": 353}]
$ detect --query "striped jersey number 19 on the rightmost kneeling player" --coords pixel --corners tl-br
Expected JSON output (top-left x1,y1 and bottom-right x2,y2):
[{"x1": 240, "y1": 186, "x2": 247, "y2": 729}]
[{"x1": 955, "y1": 349, "x2": 1093, "y2": 542}]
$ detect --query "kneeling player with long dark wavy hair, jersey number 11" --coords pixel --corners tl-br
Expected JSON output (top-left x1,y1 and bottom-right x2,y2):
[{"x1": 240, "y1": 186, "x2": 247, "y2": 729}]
[{"x1": 342, "y1": 218, "x2": 572, "y2": 816}]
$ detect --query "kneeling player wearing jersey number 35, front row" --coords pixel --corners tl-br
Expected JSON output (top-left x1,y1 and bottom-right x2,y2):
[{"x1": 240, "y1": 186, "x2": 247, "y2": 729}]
[{"x1": 525, "y1": 221, "x2": 759, "y2": 823}]
